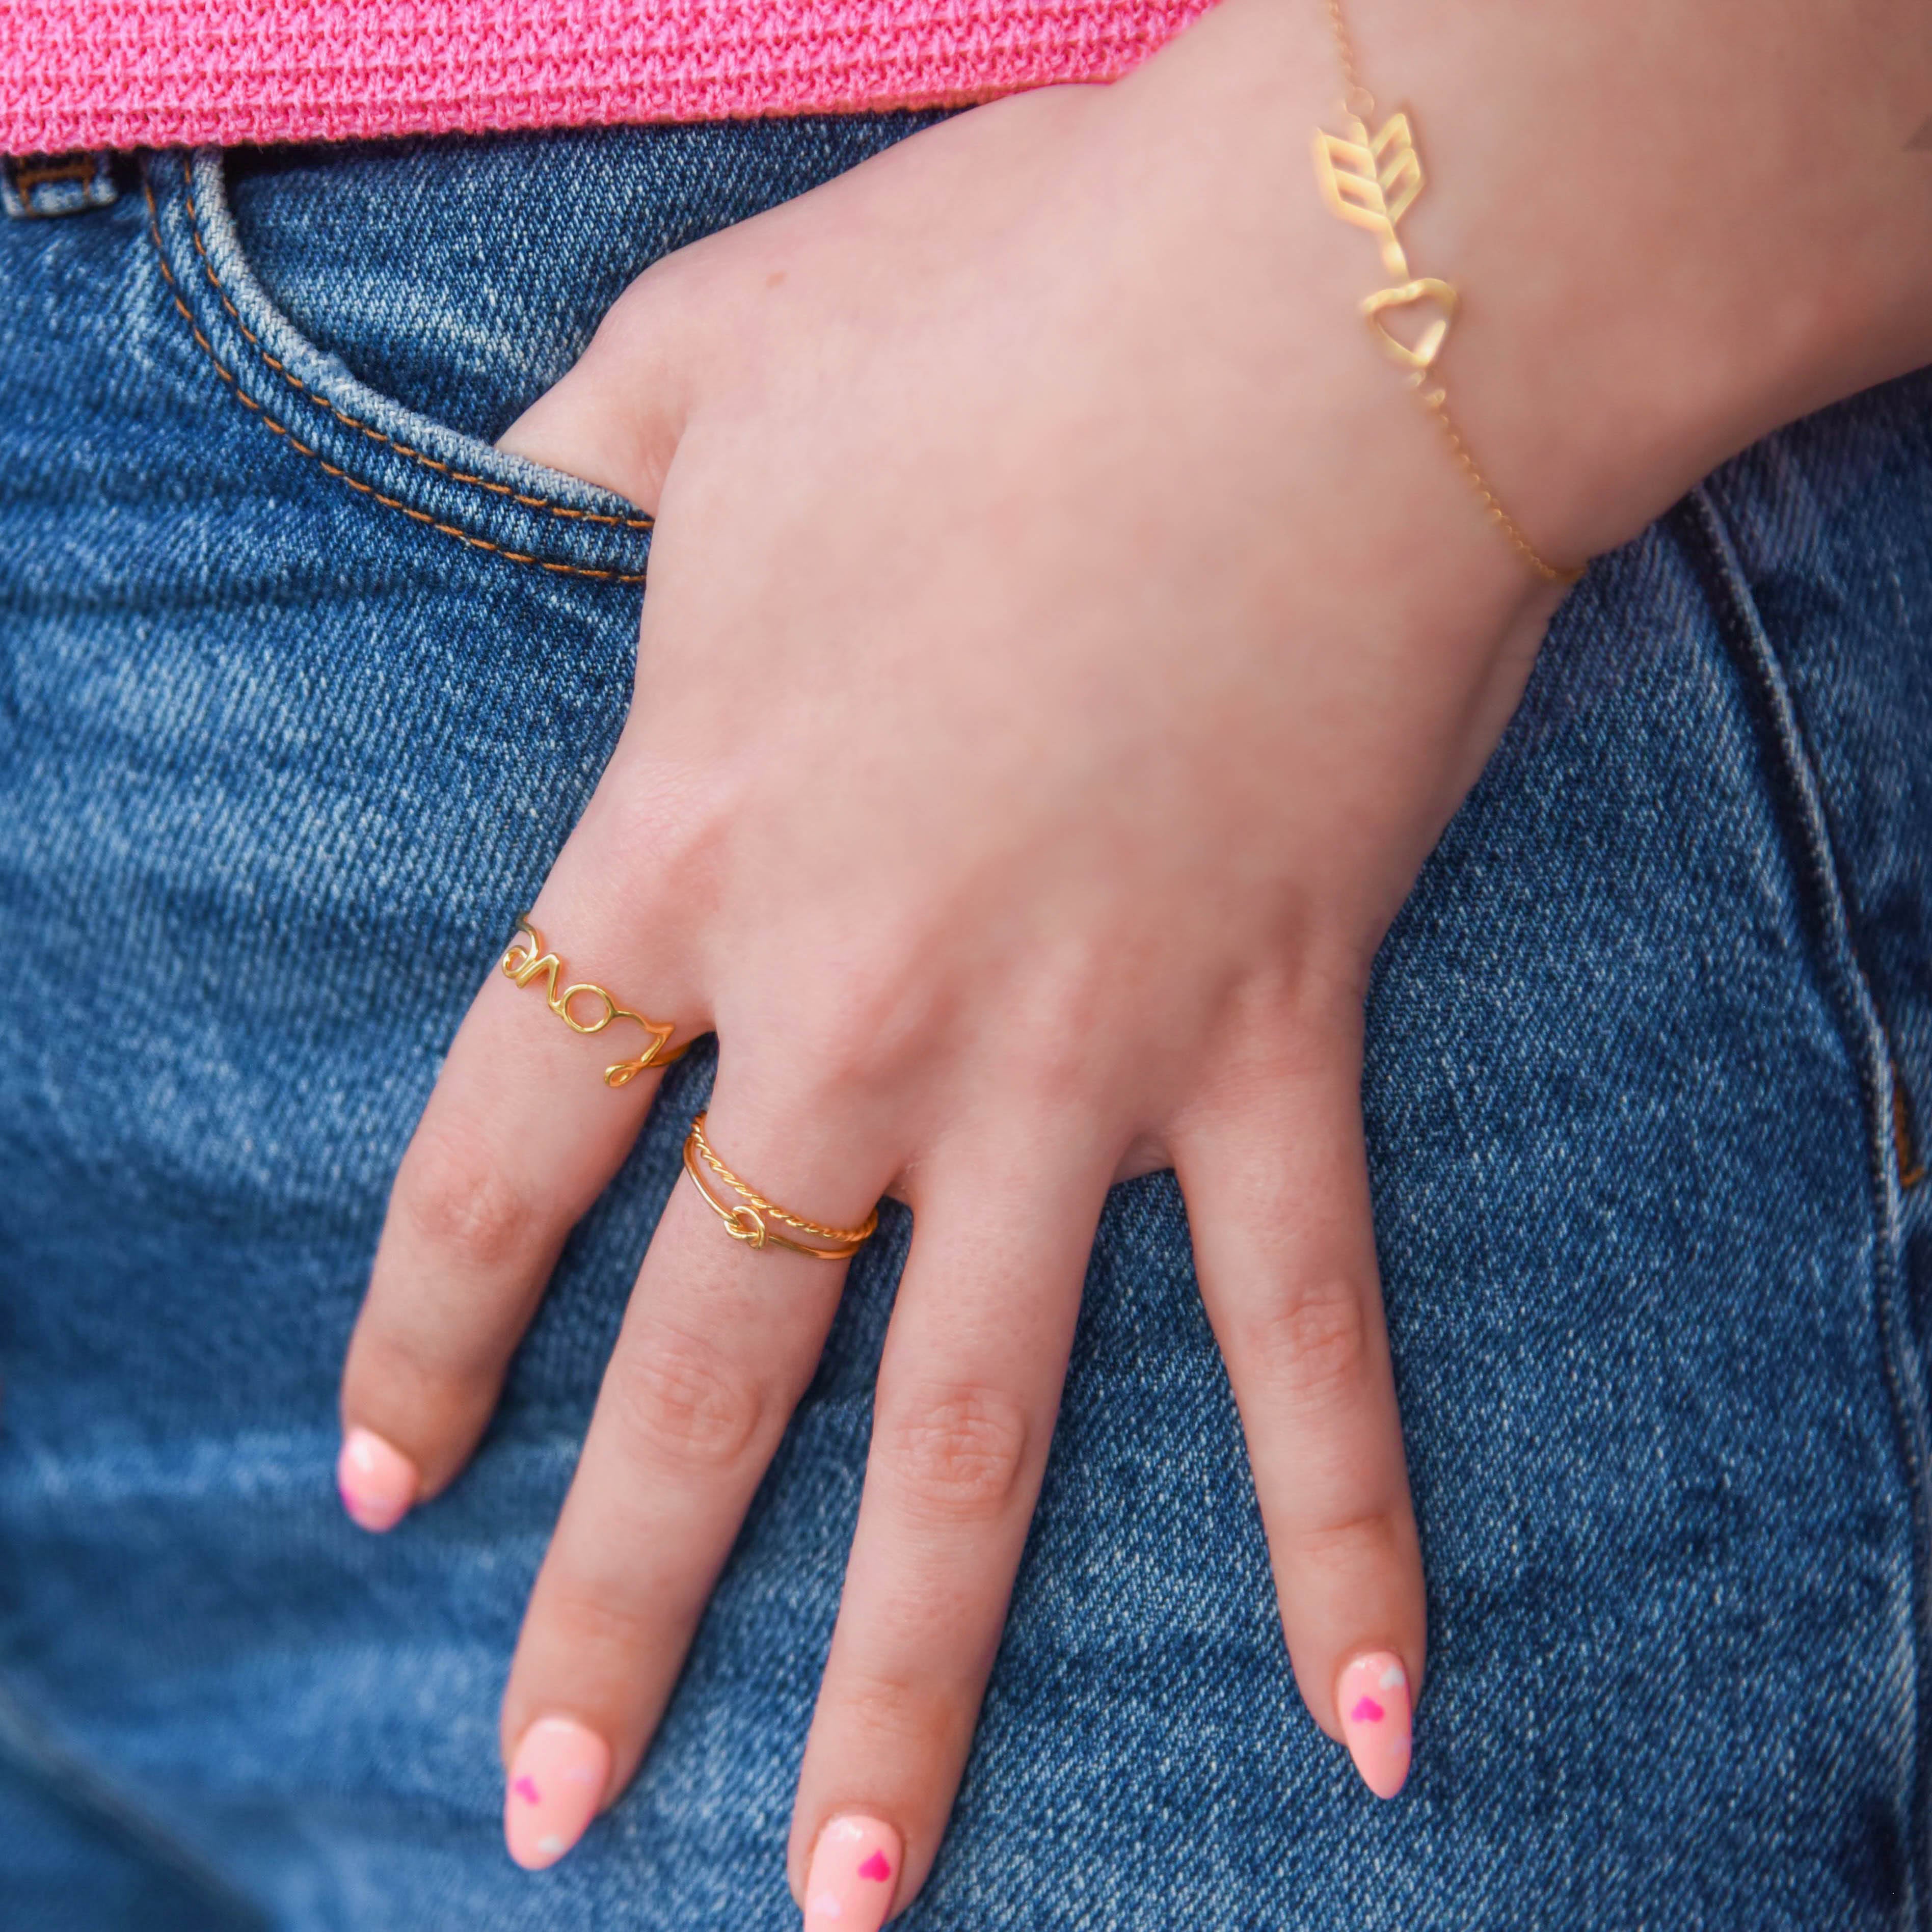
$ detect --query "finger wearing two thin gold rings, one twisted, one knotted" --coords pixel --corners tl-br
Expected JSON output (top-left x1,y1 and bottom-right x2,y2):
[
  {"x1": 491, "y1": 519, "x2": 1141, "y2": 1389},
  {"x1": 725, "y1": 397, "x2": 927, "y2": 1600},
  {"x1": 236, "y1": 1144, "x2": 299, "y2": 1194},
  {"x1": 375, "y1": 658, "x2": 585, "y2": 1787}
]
[{"x1": 502, "y1": 1066, "x2": 896, "y2": 1868}]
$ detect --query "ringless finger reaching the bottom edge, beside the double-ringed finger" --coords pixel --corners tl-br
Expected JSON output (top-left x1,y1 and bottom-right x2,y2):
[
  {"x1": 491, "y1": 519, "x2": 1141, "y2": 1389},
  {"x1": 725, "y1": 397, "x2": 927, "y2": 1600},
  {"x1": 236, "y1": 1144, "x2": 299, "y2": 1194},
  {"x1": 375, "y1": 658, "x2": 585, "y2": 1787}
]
[{"x1": 790, "y1": 1130, "x2": 1117, "y2": 1932}]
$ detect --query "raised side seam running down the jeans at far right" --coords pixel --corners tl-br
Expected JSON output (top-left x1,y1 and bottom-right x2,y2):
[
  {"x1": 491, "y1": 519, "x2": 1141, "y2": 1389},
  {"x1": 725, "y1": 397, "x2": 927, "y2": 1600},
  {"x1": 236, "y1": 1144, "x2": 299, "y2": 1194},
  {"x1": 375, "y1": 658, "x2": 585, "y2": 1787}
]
[{"x1": 1679, "y1": 485, "x2": 1932, "y2": 1932}]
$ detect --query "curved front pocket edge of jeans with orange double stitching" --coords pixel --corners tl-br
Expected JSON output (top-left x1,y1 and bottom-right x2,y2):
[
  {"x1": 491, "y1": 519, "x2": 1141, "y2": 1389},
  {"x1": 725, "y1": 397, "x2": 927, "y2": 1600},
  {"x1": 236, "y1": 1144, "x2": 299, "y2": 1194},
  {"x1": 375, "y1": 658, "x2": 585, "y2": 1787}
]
[{"x1": 143, "y1": 149, "x2": 651, "y2": 583}]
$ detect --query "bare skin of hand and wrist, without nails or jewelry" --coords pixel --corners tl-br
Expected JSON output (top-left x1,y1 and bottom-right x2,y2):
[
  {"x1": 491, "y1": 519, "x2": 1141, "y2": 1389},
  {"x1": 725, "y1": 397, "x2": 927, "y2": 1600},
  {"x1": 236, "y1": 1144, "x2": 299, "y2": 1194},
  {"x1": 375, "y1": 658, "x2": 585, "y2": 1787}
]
[{"x1": 342, "y1": 0, "x2": 1932, "y2": 1907}]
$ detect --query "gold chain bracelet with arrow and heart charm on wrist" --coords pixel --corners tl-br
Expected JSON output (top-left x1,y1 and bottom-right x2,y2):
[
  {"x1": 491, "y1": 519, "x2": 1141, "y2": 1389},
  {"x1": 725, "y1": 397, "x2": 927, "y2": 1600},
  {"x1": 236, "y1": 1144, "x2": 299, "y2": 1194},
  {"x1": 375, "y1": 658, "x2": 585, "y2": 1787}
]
[{"x1": 1316, "y1": 0, "x2": 1582, "y2": 583}]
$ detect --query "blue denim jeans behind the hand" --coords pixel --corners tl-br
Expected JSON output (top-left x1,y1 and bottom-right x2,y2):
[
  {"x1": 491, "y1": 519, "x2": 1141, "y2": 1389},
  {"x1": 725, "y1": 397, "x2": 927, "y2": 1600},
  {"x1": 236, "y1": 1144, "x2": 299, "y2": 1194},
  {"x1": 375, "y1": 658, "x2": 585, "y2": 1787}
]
[{"x1": 0, "y1": 120, "x2": 1932, "y2": 1932}]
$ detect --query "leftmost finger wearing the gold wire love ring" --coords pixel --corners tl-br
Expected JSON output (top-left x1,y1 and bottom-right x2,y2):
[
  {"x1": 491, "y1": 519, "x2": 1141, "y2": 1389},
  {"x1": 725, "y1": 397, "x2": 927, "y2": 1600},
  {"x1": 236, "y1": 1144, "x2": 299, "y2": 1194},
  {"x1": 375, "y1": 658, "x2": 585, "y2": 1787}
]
[{"x1": 338, "y1": 838, "x2": 701, "y2": 1530}]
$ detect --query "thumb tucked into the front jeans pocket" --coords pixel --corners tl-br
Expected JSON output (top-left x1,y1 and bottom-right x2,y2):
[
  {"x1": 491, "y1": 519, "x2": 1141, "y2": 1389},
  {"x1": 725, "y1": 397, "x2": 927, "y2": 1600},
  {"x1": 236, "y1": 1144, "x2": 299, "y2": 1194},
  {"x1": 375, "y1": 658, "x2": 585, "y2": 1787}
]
[{"x1": 497, "y1": 257, "x2": 692, "y2": 516}]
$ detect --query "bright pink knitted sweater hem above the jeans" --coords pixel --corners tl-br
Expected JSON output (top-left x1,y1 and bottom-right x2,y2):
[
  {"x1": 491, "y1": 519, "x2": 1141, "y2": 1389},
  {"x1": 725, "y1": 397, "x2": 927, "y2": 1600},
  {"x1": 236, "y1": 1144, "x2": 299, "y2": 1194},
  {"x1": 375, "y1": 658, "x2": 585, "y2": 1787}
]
[{"x1": 0, "y1": 0, "x2": 1212, "y2": 154}]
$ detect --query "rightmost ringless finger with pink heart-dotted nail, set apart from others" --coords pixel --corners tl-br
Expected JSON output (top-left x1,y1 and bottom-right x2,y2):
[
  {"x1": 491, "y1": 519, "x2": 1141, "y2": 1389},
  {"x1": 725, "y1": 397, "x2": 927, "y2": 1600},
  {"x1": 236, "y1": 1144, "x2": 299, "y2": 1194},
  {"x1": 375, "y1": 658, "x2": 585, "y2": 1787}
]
[{"x1": 1175, "y1": 1016, "x2": 1426, "y2": 1797}]
